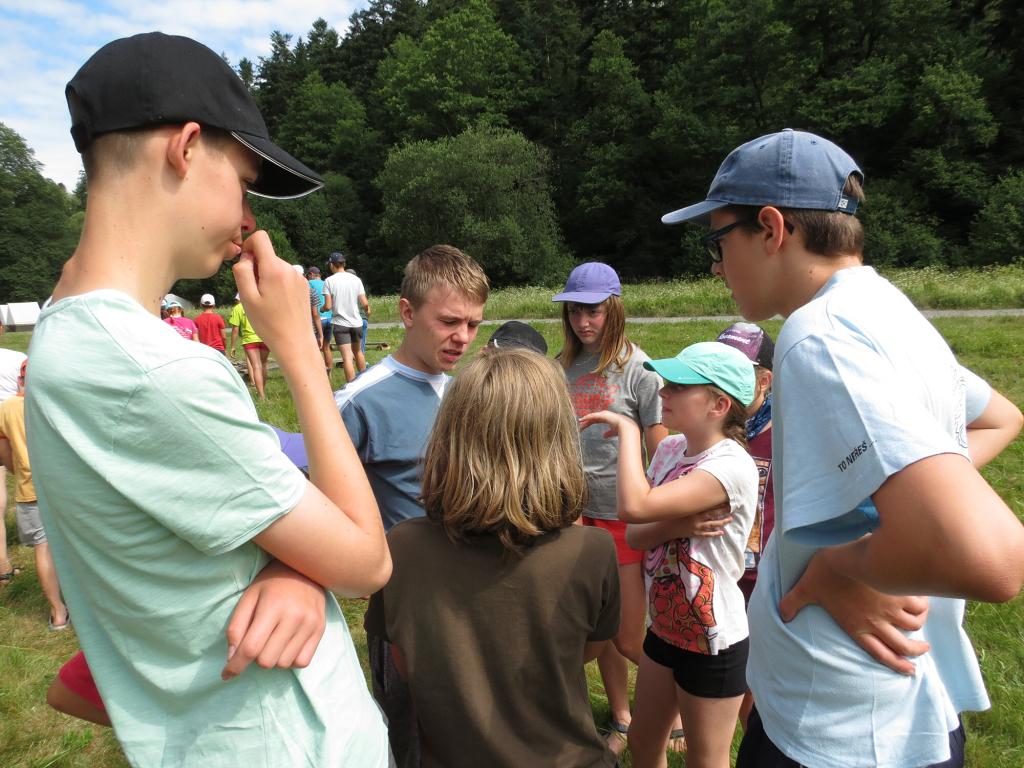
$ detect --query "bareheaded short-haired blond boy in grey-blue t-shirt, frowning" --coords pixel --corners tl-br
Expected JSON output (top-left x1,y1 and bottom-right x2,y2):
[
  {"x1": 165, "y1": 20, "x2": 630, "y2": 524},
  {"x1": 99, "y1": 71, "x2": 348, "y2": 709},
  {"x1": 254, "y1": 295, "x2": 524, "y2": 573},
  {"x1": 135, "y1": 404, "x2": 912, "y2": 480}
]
[{"x1": 335, "y1": 246, "x2": 489, "y2": 768}]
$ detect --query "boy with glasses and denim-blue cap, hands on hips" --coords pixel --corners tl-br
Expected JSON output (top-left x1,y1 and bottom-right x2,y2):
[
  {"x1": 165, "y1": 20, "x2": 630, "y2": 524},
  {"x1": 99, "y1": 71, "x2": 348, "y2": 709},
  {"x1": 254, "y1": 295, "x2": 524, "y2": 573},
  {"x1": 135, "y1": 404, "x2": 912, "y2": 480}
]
[{"x1": 663, "y1": 129, "x2": 1024, "y2": 768}]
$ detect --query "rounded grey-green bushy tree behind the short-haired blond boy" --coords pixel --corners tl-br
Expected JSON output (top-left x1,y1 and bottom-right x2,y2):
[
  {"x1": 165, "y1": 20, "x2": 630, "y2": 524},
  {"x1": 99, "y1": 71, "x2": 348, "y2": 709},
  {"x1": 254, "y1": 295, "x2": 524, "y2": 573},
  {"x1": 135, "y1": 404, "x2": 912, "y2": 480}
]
[{"x1": 377, "y1": 127, "x2": 571, "y2": 287}]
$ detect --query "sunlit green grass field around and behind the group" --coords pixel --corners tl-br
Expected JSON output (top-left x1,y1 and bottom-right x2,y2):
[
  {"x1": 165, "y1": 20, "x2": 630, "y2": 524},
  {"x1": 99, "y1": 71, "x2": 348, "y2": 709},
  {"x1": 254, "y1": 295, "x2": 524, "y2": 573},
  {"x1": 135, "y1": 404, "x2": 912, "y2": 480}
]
[{"x1": 0, "y1": 313, "x2": 1024, "y2": 768}]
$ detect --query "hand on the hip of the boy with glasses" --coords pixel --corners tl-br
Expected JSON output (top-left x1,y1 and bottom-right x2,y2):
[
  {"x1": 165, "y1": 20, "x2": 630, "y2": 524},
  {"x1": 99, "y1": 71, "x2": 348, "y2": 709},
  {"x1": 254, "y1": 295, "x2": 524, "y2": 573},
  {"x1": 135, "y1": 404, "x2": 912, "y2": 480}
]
[{"x1": 778, "y1": 552, "x2": 931, "y2": 675}]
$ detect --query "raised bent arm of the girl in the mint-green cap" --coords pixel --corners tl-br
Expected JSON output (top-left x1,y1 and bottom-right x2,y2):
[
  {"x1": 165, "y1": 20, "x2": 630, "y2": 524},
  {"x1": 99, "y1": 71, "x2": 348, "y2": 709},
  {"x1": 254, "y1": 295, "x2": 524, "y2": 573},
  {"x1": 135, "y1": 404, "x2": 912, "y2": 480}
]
[{"x1": 580, "y1": 411, "x2": 729, "y2": 522}]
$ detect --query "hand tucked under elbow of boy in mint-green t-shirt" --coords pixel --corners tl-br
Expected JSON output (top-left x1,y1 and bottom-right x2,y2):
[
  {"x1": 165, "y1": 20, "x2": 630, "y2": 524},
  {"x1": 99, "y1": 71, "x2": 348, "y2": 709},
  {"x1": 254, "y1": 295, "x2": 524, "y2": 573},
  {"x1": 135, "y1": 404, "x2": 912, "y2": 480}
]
[{"x1": 220, "y1": 560, "x2": 327, "y2": 680}]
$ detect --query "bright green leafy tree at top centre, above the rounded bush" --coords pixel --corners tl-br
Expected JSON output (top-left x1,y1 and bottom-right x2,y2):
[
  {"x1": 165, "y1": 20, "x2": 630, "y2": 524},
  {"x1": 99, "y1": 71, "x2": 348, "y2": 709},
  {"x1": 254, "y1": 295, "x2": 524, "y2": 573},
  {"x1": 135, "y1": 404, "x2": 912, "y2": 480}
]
[{"x1": 377, "y1": 0, "x2": 523, "y2": 138}]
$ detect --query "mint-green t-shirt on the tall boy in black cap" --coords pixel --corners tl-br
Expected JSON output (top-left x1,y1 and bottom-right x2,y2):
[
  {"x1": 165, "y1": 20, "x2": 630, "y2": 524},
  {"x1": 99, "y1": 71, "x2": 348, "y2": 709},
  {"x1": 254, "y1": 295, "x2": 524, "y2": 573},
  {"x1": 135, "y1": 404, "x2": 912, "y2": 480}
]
[{"x1": 26, "y1": 290, "x2": 388, "y2": 768}]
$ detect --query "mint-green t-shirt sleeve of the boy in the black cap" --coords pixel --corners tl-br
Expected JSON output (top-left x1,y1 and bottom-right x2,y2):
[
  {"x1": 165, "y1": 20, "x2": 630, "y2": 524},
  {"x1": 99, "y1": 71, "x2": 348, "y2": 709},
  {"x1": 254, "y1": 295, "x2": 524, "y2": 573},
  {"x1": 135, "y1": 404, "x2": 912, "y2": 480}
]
[{"x1": 110, "y1": 357, "x2": 306, "y2": 555}]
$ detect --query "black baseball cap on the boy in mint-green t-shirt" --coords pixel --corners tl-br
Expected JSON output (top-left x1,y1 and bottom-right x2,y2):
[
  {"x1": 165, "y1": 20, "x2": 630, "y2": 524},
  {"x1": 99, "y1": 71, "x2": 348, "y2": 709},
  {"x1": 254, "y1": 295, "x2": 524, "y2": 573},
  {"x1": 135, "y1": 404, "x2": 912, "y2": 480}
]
[{"x1": 65, "y1": 32, "x2": 324, "y2": 199}]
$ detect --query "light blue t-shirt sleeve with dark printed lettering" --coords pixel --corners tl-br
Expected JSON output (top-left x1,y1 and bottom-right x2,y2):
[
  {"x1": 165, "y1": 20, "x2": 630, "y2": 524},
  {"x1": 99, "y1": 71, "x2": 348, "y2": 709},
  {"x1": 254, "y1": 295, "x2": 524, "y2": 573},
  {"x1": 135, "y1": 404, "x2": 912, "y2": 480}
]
[{"x1": 775, "y1": 334, "x2": 966, "y2": 546}]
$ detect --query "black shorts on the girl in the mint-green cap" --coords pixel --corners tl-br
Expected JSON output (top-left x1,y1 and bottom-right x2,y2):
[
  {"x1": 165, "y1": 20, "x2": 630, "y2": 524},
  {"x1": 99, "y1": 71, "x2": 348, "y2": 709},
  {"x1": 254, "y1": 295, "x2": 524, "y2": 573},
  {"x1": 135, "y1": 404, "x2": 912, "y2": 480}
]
[{"x1": 643, "y1": 630, "x2": 751, "y2": 698}]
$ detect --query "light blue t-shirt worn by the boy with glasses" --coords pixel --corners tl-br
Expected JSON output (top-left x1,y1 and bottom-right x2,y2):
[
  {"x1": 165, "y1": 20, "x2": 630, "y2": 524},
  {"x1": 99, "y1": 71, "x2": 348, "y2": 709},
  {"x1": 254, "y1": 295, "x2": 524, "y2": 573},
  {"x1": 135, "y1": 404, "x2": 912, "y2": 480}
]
[{"x1": 746, "y1": 267, "x2": 988, "y2": 768}]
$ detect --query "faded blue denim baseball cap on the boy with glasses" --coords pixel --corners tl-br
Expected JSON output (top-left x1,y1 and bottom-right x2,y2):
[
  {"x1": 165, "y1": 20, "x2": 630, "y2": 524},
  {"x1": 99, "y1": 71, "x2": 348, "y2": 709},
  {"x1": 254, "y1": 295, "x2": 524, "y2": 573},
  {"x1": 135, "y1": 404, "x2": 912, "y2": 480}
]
[{"x1": 662, "y1": 128, "x2": 864, "y2": 224}]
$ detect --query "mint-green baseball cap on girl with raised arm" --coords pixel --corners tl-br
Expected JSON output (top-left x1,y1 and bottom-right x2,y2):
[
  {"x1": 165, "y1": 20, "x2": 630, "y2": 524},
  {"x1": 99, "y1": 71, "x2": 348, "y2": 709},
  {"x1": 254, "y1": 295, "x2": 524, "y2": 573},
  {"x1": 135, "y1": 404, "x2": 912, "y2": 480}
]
[{"x1": 643, "y1": 341, "x2": 757, "y2": 408}]
